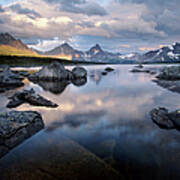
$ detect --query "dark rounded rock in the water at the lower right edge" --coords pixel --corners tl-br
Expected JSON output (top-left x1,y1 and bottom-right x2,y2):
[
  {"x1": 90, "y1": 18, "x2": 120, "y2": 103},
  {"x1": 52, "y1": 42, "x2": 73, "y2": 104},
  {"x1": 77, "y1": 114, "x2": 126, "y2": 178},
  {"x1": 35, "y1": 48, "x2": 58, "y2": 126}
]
[{"x1": 150, "y1": 107, "x2": 180, "y2": 129}]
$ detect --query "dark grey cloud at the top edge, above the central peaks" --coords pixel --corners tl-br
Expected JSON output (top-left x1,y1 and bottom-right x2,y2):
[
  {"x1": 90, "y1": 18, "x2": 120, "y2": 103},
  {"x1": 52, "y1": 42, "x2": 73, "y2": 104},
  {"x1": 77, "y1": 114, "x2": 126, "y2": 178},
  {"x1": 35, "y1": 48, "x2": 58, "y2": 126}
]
[{"x1": 45, "y1": 0, "x2": 107, "y2": 16}]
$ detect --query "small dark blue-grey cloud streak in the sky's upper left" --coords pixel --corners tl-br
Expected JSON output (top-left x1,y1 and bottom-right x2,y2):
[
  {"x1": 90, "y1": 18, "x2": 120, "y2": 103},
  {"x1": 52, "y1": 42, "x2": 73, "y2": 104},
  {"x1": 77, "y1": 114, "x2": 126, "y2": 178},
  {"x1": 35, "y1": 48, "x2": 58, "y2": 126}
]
[{"x1": 9, "y1": 4, "x2": 41, "y2": 17}]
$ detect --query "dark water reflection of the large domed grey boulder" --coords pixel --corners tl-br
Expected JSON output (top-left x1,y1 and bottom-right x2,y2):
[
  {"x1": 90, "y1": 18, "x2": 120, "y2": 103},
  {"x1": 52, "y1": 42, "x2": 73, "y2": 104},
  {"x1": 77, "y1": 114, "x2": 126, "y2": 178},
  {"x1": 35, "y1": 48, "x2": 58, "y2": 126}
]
[{"x1": 34, "y1": 80, "x2": 70, "y2": 94}]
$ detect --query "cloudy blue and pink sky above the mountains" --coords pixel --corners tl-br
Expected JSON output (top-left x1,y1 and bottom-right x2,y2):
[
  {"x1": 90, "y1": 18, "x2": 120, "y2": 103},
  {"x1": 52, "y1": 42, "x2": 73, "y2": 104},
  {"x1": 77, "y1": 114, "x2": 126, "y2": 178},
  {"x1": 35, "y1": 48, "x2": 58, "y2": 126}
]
[{"x1": 0, "y1": 0, "x2": 180, "y2": 53}]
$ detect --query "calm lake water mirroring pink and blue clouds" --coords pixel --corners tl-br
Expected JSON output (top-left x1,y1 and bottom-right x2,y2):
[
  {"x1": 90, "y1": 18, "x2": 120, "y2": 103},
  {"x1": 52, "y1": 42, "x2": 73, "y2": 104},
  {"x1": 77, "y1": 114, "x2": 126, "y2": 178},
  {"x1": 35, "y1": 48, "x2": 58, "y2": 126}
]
[{"x1": 0, "y1": 65, "x2": 180, "y2": 179}]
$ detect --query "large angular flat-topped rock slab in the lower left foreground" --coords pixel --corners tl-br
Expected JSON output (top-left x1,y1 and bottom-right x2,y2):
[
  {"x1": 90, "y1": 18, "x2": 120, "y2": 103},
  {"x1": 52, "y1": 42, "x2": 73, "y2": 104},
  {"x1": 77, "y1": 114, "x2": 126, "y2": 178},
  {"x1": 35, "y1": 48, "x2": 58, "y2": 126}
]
[{"x1": 0, "y1": 111, "x2": 44, "y2": 157}]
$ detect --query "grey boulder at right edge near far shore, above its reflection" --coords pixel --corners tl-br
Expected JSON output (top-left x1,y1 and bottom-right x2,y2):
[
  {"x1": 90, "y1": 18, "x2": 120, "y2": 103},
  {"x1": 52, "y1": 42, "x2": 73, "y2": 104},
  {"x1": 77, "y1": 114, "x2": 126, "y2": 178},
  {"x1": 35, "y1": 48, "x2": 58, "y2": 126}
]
[{"x1": 157, "y1": 66, "x2": 180, "y2": 81}]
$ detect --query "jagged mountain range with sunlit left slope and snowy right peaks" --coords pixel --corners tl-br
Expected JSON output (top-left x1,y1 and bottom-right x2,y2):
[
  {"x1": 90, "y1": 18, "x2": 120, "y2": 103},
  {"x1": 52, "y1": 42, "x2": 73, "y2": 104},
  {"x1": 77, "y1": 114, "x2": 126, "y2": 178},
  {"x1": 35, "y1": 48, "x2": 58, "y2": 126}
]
[{"x1": 0, "y1": 33, "x2": 180, "y2": 63}]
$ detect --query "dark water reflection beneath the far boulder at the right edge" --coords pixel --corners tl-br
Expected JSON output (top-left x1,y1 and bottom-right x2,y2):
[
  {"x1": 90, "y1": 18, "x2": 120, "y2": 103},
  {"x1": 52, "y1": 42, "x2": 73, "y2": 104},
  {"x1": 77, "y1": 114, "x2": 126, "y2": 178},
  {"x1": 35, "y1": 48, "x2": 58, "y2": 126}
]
[{"x1": 153, "y1": 79, "x2": 180, "y2": 93}]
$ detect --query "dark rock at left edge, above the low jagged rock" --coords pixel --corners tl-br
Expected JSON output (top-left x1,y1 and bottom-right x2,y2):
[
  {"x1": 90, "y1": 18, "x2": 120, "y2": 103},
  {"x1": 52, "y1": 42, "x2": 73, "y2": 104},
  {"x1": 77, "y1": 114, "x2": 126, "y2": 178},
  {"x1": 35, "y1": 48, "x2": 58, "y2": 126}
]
[{"x1": 0, "y1": 66, "x2": 24, "y2": 92}]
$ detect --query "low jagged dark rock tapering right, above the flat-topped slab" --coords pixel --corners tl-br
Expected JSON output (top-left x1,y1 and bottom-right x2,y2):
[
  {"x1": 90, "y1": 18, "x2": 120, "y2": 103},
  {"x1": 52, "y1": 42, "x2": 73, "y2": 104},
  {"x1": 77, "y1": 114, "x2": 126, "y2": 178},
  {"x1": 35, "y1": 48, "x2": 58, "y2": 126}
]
[{"x1": 7, "y1": 89, "x2": 58, "y2": 108}]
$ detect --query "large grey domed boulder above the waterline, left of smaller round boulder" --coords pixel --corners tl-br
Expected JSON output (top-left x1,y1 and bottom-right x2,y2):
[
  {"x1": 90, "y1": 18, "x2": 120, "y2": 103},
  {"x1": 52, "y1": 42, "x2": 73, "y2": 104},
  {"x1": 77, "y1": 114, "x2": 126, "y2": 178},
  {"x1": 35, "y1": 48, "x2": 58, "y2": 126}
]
[{"x1": 28, "y1": 62, "x2": 72, "y2": 81}]
